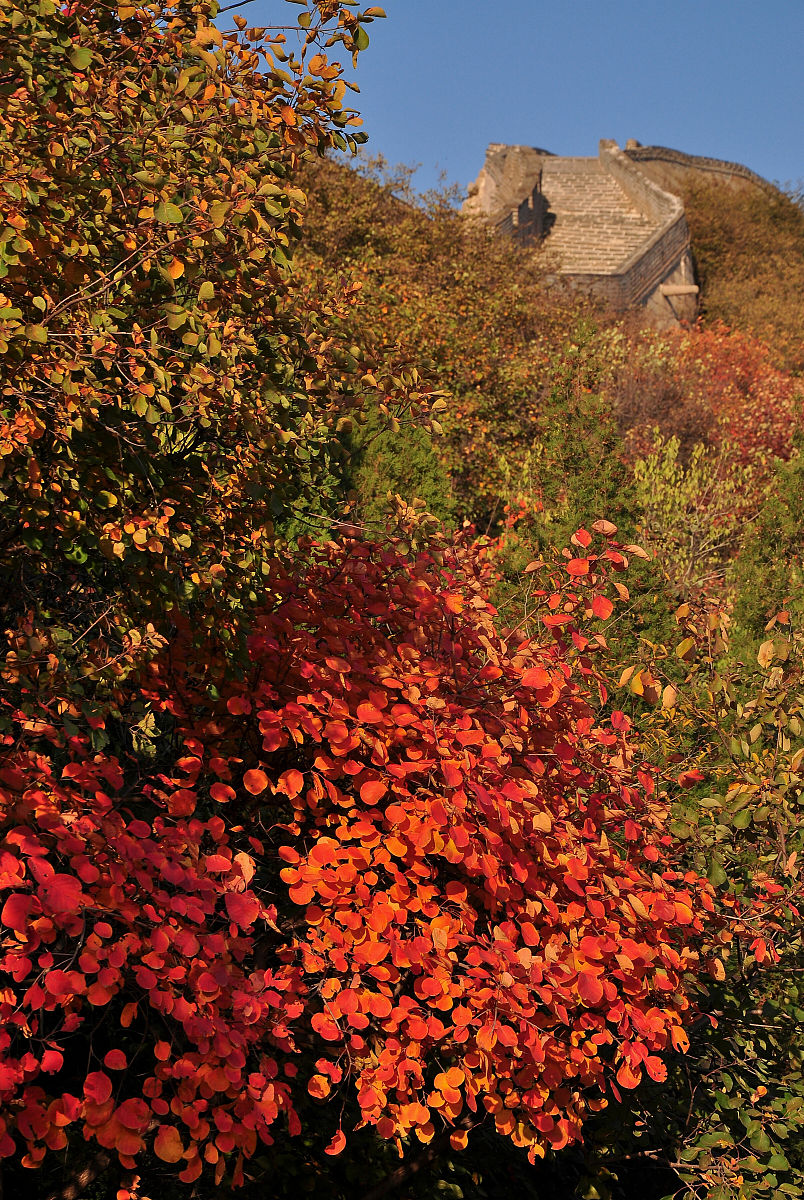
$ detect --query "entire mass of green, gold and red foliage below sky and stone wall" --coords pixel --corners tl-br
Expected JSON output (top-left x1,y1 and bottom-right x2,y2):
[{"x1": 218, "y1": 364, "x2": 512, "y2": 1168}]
[{"x1": 0, "y1": 0, "x2": 804, "y2": 1200}]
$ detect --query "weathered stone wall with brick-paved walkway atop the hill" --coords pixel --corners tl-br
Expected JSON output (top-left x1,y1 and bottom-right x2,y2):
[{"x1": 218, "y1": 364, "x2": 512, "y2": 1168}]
[{"x1": 464, "y1": 139, "x2": 775, "y2": 326}]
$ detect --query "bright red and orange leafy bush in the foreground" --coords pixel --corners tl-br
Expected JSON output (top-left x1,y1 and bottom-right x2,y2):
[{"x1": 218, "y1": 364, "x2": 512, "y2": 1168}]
[{"x1": 0, "y1": 532, "x2": 712, "y2": 1180}]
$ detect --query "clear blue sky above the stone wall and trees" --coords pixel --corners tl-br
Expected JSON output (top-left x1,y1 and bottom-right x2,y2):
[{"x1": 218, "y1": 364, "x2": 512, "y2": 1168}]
[{"x1": 261, "y1": 0, "x2": 804, "y2": 188}]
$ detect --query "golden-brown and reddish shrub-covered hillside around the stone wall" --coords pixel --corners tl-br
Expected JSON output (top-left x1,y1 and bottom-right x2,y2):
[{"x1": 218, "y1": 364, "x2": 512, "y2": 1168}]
[{"x1": 300, "y1": 153, "x2": 799, "y2": 528}]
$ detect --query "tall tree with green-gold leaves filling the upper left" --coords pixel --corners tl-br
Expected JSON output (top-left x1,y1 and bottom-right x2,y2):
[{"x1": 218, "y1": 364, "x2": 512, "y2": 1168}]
[{"x1": 0, "y1": 0, "x2": 414, "y2": 710}]
